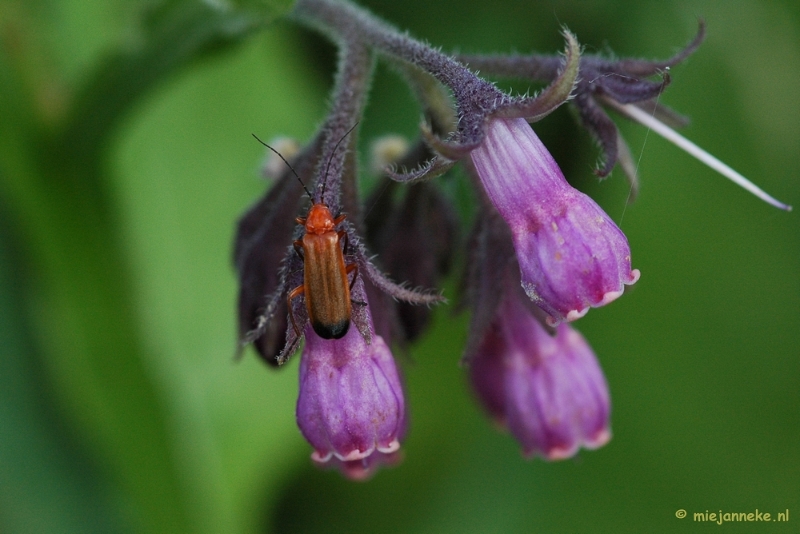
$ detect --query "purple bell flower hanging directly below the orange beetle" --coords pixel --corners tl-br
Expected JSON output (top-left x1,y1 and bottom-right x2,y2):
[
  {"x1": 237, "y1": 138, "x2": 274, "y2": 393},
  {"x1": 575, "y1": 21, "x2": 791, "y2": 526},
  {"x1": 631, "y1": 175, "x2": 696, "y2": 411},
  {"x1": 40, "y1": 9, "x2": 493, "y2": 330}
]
[{"x1": 297, "y1": 310, "x2": 406, "y2": 479}]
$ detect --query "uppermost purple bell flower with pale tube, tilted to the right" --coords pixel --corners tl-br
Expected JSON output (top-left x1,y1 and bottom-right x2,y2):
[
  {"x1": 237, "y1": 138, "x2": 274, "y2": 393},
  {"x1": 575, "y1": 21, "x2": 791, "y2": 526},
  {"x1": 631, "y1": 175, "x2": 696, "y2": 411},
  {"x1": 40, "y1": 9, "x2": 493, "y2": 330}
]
[{"x1": 470, "y1": 119, "x2": 639, "y2": 325}]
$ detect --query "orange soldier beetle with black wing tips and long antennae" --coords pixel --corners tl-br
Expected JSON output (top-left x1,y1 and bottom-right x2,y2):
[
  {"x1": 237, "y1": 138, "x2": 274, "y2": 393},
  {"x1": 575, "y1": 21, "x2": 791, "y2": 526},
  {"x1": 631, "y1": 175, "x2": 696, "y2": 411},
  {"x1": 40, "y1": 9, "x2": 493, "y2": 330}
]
[{"x1": 253, "y1": 123, "x2": 358, "y2": 339}]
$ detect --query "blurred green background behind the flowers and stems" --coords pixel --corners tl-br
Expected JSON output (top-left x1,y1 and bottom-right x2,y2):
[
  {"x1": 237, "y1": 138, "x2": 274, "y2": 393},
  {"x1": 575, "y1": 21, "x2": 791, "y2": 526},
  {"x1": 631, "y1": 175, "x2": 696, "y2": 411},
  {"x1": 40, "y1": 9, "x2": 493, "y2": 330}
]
[{"x1": 0, "y1": 0, "x2": 800, "y2": 533}]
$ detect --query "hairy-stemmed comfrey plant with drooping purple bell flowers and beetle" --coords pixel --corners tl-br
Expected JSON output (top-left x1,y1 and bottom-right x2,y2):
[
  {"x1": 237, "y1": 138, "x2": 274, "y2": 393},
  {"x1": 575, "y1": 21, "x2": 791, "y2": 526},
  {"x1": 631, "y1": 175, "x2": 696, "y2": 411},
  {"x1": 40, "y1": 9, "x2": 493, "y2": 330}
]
[{"x1": 234, "y1": 0, "x2": 789, "y2": 479}]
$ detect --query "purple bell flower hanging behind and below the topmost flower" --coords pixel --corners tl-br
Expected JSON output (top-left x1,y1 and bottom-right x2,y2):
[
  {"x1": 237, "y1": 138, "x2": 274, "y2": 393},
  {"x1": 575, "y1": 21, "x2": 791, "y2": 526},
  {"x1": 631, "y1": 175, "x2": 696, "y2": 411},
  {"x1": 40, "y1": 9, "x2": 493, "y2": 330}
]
[{"x1": 470, "y1": 289, "x2": 611, "y2": 460}]
